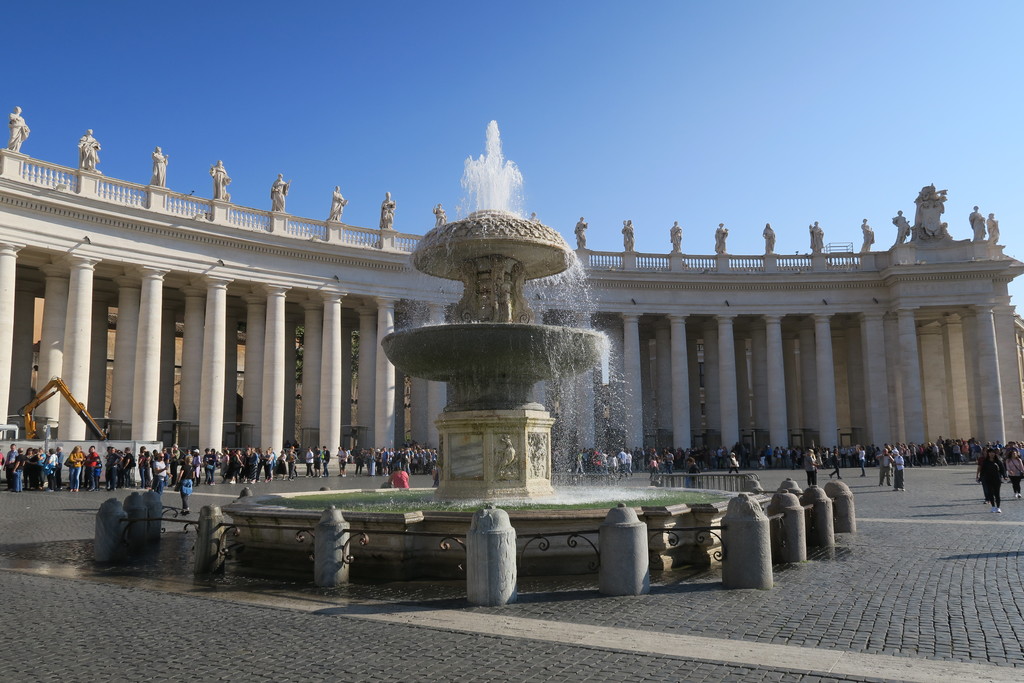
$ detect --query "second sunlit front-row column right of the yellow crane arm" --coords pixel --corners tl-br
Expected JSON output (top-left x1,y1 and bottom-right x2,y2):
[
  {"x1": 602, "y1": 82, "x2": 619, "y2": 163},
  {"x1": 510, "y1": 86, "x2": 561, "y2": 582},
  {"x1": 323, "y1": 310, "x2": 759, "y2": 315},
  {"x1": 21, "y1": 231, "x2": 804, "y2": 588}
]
[{"x1": 197, "y1": 278, "x2": 230, "y2": 451}]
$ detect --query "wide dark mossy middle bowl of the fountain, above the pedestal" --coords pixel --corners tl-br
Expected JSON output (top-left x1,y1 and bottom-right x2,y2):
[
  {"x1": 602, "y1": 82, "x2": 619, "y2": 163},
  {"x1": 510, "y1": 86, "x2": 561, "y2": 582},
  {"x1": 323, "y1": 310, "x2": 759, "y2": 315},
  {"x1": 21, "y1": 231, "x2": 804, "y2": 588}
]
[{"x1": 381, "y1": 323, "x2": 606, "y2": 384}]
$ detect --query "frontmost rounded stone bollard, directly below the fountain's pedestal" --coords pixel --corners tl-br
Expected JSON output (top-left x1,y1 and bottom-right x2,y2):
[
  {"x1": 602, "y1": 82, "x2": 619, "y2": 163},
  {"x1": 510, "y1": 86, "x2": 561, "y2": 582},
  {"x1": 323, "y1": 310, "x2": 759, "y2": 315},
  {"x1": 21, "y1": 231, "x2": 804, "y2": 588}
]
[{"x1": 466, "y1": 505, "x2": 517, "y2": 606}]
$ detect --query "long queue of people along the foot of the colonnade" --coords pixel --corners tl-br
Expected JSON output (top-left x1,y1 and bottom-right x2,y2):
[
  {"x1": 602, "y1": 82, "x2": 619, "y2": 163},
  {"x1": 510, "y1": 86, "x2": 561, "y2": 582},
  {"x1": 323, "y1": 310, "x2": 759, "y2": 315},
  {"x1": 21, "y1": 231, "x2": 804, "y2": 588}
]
[{"x1": 4, "y1": 437, "x2": 1024, "y2": 512}]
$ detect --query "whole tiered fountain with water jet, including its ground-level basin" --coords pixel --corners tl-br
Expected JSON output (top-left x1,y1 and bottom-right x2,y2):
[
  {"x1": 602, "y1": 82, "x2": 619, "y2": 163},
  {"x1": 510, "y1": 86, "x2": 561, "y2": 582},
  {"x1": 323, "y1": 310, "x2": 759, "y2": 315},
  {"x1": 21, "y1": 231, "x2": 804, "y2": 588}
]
[{"x1": 224, "y1": 122, "x2": 737, "y2": 580}]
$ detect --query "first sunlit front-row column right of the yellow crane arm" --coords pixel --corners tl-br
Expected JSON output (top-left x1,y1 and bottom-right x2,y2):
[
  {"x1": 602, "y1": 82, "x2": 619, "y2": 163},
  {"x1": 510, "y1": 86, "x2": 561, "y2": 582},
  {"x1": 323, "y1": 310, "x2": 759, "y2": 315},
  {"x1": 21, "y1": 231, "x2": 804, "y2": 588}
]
[{"x1": 131, "y1": 268, "x2": 167, "y2": 441}]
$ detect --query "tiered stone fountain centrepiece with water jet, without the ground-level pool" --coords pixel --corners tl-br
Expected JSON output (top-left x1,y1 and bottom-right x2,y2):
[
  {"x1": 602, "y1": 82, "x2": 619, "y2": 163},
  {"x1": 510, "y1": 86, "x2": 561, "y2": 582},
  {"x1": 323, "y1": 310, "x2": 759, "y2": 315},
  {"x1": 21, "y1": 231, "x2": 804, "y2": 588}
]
[{"x1": 381, "y1": 121, "x2": 605, "y2": 501}]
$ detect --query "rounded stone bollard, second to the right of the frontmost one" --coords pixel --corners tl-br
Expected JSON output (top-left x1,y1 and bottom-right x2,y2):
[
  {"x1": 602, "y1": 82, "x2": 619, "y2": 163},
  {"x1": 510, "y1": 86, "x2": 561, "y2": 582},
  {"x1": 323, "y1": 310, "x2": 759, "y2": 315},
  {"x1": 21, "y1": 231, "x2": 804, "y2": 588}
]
[{"x1": 722, "y1": 494, "x2": 772, "y2": 588}]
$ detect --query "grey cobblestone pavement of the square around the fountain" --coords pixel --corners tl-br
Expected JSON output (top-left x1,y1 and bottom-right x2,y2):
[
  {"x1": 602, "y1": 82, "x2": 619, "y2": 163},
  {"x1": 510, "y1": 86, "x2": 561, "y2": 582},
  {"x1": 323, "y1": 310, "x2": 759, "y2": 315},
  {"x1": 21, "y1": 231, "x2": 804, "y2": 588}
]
[{"x1": 0, "y1": 467, "x2": 1024, "y2": 681}]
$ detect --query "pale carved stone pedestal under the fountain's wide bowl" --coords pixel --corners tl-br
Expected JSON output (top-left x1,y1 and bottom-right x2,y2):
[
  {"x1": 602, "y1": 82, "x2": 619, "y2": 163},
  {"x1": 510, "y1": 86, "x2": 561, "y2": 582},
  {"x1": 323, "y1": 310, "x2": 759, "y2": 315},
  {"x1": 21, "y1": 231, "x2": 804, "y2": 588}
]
[{"x1": 435, "y1": 409, "x2": 555, "y2": 500}]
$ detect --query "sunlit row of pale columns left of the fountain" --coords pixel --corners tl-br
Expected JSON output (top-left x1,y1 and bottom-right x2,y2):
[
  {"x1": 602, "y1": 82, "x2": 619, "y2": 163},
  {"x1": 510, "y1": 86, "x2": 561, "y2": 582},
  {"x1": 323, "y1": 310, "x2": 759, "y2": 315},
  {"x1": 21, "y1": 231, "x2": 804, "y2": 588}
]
[{"x1": 0, "y1": 244, "x2": 444, "y2": 449}]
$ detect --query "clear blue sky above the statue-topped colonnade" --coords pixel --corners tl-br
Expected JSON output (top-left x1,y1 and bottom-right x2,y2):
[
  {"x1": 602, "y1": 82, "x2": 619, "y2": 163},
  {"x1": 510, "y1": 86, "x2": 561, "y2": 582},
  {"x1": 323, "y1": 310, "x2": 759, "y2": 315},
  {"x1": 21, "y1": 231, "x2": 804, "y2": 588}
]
[{"x1": 8, "y1": 0, "x2": 1024, "y2": 295}]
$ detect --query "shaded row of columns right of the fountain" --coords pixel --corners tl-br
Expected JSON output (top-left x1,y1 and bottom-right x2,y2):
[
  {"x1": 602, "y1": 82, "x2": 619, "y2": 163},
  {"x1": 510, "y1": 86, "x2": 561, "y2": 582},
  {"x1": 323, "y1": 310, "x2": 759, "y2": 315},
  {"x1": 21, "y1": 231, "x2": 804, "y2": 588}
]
[{"x1": 606, "y1": 305, "x2": 1024, "y2": 447}]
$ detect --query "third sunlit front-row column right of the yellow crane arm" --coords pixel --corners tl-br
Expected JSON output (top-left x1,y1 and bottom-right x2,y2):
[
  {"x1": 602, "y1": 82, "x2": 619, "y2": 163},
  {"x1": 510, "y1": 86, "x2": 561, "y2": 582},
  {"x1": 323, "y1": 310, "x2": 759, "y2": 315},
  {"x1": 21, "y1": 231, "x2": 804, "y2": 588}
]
[{"x1": 259, "y1": 287, "x2": 289, "y2": 451}]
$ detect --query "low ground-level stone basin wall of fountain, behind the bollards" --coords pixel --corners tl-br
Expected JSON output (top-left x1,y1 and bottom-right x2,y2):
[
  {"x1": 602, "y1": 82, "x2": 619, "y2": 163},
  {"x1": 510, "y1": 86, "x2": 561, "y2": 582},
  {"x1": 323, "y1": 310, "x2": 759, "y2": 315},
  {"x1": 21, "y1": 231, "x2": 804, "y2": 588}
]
[{"x1": 223, "y1": 494, "x2": 728, "y2": 581}]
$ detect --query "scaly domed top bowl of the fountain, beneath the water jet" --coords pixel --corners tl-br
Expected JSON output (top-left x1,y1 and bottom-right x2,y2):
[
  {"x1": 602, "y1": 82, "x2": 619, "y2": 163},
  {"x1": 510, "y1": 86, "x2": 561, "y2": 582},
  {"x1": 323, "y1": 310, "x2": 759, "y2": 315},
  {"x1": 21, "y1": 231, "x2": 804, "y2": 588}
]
[{"x1": 413, "y1": 210, "x2": 571, "y2": 280}]
